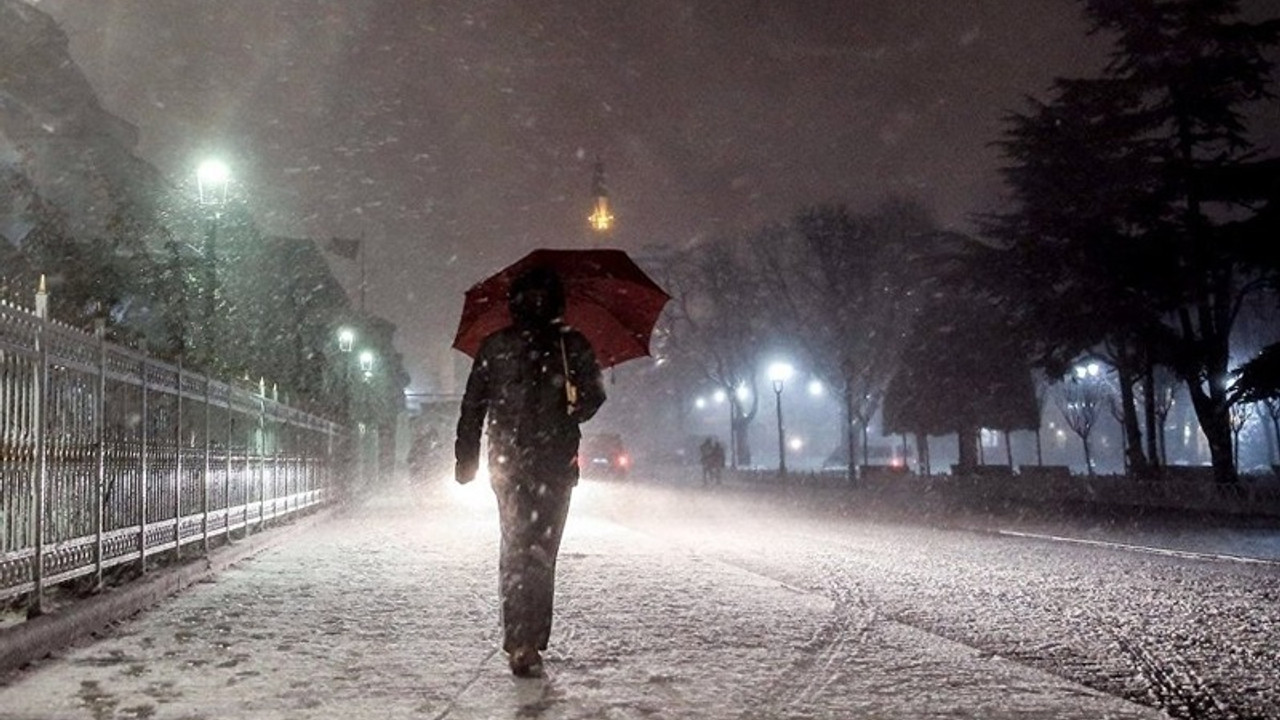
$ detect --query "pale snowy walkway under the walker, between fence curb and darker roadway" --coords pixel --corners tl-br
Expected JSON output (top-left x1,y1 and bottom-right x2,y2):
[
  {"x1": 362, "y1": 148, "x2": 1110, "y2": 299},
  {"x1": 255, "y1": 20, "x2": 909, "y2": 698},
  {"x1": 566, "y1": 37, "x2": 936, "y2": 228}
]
[{"x1": 0, "y1": 476, "x2": 1161, "y2": 720}]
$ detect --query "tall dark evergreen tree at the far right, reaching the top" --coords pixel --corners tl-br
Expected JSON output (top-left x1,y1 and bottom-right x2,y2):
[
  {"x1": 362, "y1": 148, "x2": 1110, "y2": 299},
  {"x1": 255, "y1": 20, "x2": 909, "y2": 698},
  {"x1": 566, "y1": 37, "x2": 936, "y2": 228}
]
[{"x1": 988, "y1": 0, "x2": 1280, "y2": 482}]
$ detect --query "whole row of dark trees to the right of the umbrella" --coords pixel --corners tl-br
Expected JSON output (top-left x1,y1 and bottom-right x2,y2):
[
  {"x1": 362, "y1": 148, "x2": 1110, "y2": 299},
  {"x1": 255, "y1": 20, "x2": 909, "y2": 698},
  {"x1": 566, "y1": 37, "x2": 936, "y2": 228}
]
[{"x1": 659, "y1": 0, "x2": 1280, "y2": 482}]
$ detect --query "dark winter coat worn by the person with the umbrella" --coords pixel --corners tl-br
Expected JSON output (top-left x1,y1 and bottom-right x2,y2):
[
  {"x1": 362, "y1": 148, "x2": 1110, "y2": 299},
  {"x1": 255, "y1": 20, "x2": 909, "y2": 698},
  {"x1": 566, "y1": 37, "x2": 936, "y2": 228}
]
[{"x1": 456, "y1": 322, "x2": 604, "y2": 487}]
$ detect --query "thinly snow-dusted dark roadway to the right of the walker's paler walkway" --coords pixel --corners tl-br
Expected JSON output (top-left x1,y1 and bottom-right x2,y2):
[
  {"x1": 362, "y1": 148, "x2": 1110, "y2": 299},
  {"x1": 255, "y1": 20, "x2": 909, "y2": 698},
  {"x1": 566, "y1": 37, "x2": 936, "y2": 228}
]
[{"x1": 599, "y1": 476, "x2": 1280, "y2": 719}]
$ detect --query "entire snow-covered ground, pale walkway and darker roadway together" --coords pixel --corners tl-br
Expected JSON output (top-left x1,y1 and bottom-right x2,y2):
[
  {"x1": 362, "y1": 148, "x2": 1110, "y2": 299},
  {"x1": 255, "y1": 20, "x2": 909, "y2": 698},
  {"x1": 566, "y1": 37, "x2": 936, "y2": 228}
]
[{"x1": 0, "y1": 471, "x2": 1280, "y2": 720}]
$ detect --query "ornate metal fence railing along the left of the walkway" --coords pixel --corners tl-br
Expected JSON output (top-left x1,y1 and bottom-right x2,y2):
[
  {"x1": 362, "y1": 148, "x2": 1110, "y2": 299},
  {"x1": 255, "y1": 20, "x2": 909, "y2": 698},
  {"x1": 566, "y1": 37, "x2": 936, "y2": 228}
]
[{"x1": 0, "y1": 304, "x2": 342, "y2": 614}]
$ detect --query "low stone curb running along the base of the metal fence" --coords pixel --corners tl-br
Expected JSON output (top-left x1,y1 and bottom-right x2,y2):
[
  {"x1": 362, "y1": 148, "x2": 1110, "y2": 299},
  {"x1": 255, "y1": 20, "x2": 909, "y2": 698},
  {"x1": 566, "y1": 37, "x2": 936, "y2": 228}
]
[{"x1": 0, "y1": 506, "x2": 335, "y2": 675}]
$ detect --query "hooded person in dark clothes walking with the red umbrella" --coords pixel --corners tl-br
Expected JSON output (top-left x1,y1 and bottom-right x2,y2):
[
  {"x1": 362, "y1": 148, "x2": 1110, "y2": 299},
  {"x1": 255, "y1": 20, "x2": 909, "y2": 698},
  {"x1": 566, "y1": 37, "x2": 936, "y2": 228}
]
[{"x1": 454, "y1": 268, "x2": 605, "y2": 676}]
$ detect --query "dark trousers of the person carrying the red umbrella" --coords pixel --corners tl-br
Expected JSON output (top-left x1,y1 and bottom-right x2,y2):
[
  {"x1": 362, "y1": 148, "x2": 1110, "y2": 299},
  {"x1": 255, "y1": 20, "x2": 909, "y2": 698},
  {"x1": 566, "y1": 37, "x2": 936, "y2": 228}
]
[{"x1": 494, "y1": 482, "x2": 573, "y2": 652}]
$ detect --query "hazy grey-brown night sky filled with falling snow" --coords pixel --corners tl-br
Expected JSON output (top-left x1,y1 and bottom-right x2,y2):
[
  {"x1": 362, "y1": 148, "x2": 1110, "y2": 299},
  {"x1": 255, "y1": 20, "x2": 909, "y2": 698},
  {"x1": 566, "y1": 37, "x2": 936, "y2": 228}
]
[{"x1": 30, "y1": 0, "x2": 1280, "y2": 391}]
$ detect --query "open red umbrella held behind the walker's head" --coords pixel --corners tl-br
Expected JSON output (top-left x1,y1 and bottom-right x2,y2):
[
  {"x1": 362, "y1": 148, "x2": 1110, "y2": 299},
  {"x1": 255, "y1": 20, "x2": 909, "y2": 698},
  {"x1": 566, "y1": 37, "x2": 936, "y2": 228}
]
[{"x1": 453, "y1": 250, "x2": 671, "y2": 368}]
